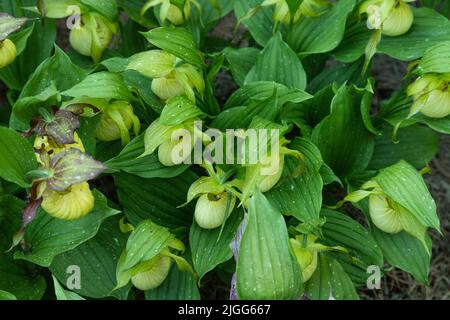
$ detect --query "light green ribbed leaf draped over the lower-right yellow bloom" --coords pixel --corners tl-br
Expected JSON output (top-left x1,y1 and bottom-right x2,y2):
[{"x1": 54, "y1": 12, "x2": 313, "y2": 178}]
[{"x1": 374, "y1": 160, "x2": 440, "y2": 231}]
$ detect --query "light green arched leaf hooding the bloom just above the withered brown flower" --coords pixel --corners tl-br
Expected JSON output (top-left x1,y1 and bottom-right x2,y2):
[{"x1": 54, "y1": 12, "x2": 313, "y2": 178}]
[{"x1": 61, "y1": 71, "x2": 134, "y2": 101}]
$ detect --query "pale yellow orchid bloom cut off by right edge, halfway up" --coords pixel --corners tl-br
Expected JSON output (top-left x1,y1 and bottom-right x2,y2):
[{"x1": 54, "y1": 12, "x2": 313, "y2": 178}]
[{"x1": 407, "y1": 74, "x2": 450, "y2": 118}]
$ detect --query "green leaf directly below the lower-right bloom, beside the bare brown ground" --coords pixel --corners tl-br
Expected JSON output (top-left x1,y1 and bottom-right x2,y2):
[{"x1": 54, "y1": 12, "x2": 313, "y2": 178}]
[{"x1": 372, "y1": 227, "x2": 431, "y2": 285}]
